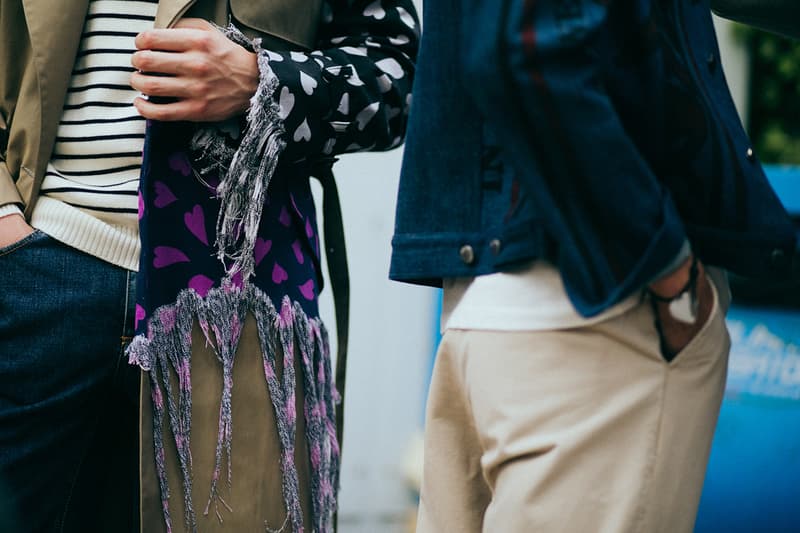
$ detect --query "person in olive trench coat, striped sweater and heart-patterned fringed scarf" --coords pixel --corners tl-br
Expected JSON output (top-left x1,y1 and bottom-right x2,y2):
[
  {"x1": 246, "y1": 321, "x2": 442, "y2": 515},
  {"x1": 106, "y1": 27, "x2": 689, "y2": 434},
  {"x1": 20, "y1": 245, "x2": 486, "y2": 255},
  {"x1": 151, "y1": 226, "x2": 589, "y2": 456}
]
[{"x1": 0, "y1": 0, "x2": 419, "y2": 532}]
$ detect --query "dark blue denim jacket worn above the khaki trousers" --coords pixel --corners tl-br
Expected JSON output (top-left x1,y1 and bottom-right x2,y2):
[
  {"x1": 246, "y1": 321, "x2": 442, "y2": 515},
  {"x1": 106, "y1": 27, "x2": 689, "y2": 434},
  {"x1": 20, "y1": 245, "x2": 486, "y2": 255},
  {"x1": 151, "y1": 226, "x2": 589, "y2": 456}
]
[{"x1": 390, "y1": 0, "x2": 800, "y2": 316}]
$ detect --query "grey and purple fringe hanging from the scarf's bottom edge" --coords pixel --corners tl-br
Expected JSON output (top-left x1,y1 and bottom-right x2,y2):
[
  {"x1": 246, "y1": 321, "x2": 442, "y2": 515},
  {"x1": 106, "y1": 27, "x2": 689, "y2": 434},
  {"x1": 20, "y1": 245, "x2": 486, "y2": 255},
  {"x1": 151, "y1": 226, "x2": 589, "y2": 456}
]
[{"x1": 127, "y1": 282, "x2": 339, "y2": 533}]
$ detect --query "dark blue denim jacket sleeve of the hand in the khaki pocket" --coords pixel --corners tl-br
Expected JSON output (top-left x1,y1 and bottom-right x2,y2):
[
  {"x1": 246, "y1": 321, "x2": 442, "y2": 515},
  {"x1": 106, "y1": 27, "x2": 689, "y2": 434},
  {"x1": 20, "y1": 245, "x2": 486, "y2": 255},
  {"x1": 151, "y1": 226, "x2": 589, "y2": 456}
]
[{"x1": 465, "y1": 0, "x2": 687, "y2": 316}]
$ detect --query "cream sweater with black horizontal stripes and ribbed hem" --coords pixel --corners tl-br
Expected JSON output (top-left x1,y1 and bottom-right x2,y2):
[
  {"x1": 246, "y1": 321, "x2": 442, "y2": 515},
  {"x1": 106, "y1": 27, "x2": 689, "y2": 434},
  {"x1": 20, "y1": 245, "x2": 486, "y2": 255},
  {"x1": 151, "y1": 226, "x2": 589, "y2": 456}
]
[{"x1": 33, "y1": 0, "x2": 157, "y2": 269}]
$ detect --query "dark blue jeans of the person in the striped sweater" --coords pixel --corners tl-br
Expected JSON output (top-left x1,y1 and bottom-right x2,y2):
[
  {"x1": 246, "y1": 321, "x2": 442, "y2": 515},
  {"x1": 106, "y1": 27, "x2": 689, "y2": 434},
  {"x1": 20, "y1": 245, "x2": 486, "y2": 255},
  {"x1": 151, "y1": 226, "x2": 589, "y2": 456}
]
[{"x1": 0, "y1": 231, "x2": 139, "y2": 533}]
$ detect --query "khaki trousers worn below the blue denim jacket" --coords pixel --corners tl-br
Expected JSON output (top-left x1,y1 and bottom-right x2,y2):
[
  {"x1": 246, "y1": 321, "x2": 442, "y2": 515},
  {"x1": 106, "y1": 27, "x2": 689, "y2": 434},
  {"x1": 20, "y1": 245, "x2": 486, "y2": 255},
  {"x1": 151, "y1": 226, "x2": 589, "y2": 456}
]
[{"x1": 417, "y1": 276, "x2": 730, "y2": 533}]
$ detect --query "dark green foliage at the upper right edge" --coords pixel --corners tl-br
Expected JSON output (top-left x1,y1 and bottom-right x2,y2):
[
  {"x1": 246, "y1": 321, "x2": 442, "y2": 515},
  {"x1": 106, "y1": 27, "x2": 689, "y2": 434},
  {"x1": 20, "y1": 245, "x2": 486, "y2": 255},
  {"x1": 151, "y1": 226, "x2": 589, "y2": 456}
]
[{"x1": 737, "y1": 26, "x2": 800, "y2": 165}]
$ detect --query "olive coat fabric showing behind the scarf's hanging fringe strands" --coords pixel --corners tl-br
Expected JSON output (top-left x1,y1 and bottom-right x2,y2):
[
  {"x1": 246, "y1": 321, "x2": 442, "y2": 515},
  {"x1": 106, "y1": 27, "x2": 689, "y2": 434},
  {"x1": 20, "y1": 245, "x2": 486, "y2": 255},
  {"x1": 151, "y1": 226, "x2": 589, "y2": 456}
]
[{"x1": 140, "y1": 316, "x2": 311, "y2": 533}]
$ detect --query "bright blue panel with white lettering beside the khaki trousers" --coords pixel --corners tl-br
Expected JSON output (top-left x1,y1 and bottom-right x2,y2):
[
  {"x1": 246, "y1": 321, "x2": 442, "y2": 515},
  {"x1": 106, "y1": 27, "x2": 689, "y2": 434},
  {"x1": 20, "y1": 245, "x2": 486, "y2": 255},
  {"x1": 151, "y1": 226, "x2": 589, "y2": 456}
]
[{"x1": 695, "y1": 307, "x2": 800, "y2": 533}]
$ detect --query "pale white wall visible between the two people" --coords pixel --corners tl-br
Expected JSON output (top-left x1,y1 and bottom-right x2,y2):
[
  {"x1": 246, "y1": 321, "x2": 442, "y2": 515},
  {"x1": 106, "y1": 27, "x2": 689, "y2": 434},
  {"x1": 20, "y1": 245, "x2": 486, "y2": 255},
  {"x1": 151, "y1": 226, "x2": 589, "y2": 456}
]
[{"x1": 315, "y1": 150, "x2": 436, "y2": 533}]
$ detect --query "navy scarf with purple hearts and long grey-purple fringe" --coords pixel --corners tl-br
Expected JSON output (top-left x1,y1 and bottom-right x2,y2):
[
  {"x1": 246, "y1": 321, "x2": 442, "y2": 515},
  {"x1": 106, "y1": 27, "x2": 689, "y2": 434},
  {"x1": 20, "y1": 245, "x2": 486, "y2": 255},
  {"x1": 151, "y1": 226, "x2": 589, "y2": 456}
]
[{"x1": 127, "y1": 27, "x2": 339, "y2": 532}]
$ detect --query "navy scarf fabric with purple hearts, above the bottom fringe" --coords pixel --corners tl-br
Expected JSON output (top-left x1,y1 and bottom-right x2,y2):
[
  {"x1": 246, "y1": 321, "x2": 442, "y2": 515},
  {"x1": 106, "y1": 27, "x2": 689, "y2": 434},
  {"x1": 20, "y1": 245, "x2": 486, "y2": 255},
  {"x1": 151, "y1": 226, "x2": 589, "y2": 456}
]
[{"x1": 136, "y1": 137, "x2": 330, "y2": 338}]
